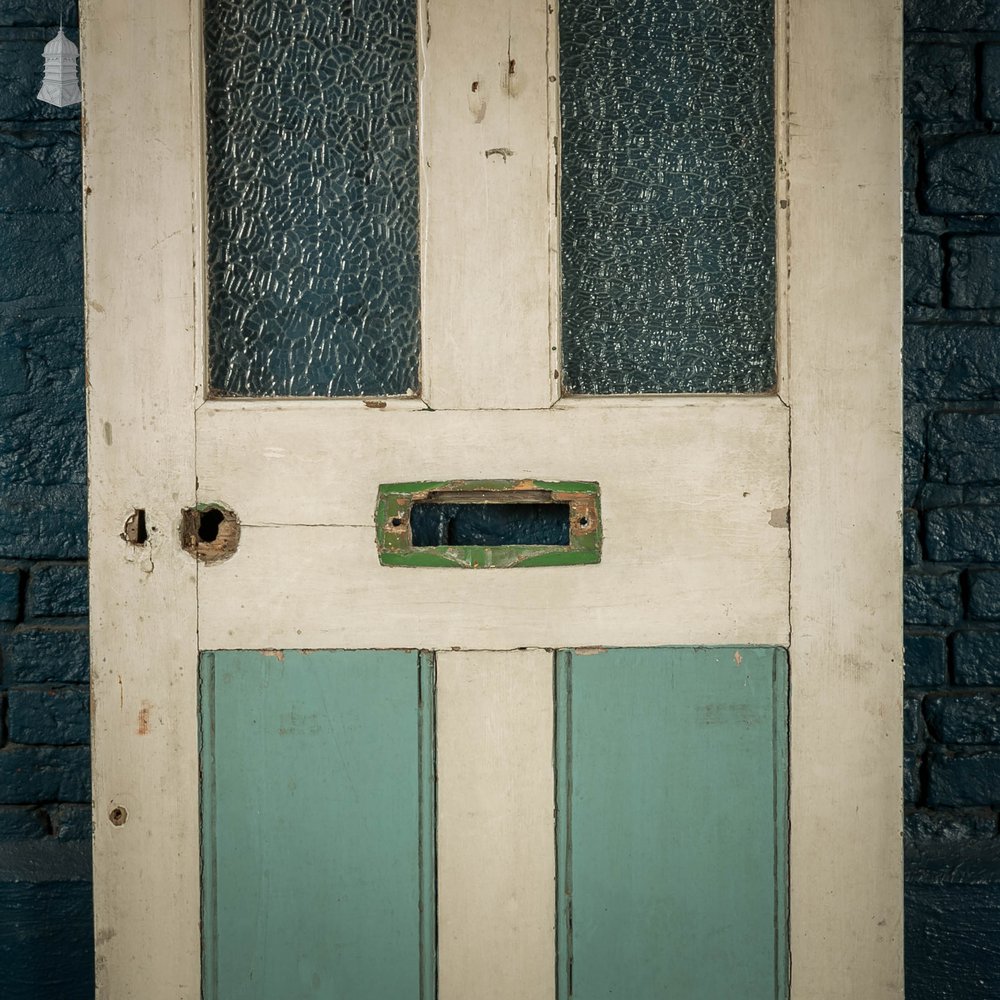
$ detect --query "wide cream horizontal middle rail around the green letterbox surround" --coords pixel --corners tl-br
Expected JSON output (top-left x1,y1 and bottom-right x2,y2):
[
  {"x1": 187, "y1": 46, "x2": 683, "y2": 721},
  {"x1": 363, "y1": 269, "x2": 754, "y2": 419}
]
[{"x1": 199, "y1": 399, "x2": 788, "y2": 648}]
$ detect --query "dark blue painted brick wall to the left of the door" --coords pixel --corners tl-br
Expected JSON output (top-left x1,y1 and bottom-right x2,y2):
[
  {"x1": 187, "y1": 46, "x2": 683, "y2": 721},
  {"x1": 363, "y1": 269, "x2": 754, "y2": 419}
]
[{"x1": 0, "y1": 0, "x2": 93, "y2": 1000}]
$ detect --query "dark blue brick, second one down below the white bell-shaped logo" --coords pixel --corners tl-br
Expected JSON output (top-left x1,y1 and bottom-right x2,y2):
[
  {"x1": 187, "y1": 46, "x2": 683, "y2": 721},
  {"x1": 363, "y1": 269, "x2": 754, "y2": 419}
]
[{"x1": 0, "y1": 212, "x2": 83, "y2": 305}]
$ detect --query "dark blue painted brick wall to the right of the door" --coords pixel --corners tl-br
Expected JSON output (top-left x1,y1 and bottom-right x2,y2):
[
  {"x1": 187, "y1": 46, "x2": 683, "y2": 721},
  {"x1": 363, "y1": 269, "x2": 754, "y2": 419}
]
[{"x1": 904, "y1": 0, "x2": 1000, "y2": 1000}]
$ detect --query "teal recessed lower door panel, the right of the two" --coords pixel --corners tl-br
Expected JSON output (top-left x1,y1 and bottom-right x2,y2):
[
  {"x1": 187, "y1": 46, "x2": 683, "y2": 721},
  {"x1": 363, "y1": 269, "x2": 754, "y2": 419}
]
[{"x1": 556, "y1": 648, "x2": 788, "y2": 1000}]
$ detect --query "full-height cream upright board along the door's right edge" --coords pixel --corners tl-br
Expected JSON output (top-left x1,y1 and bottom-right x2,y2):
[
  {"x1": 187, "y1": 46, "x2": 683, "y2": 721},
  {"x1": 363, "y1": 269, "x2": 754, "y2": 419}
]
[{"x1": 787, "y1": 0, "x2": 903, "y2": 1000}]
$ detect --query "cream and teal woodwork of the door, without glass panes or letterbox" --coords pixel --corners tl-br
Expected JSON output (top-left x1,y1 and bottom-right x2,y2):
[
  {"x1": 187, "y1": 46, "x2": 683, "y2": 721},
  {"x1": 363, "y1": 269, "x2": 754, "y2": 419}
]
[{"x1": 82, "y1": 0, "x2": 901, "y2": 1000}]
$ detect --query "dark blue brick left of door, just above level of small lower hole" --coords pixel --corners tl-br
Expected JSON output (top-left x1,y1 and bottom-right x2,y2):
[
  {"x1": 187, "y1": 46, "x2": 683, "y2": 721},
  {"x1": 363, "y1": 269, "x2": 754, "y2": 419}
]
[{"x1": 0, "y1": 745, "x2": 90, "y2": 805}]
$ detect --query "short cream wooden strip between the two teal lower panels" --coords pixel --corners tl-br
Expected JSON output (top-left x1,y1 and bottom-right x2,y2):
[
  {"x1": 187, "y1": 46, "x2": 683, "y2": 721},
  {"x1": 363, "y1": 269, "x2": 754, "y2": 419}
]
[{"x1": 436, "y1": 649, "x2": 555, "y2": 1000}]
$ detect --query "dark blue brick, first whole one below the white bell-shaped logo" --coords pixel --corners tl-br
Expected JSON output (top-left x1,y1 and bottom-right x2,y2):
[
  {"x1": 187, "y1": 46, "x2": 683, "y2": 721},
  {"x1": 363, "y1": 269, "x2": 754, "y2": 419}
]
[{"x1": 0, "y1": 126, "x2": 81, "y2": 214}]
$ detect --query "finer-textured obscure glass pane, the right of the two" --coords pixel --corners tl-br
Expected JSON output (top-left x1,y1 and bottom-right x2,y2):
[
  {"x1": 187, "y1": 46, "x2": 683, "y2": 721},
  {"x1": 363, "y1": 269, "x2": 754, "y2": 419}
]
[{"x1": 559, "y1": 0, "x2": 775, "y2": 394}]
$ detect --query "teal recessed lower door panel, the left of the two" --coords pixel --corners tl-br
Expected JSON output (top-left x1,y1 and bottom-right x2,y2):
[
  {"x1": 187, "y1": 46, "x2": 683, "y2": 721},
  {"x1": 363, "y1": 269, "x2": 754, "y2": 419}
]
[{"x1": 201, "y1": 650, "x2": 434, "y2": 1000}]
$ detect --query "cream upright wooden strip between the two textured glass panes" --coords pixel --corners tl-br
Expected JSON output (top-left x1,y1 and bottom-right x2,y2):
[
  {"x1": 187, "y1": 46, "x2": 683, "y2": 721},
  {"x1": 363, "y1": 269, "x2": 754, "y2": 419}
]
[{"x1": 420, "y1": 0, "x2": 558, "y2": 409}]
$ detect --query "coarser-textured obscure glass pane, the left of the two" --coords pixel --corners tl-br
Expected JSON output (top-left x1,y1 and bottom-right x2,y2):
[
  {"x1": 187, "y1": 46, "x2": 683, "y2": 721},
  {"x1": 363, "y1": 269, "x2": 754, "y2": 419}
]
[{"x1": 205, "y1": 0, "x2": 419, "y2": 396}]
